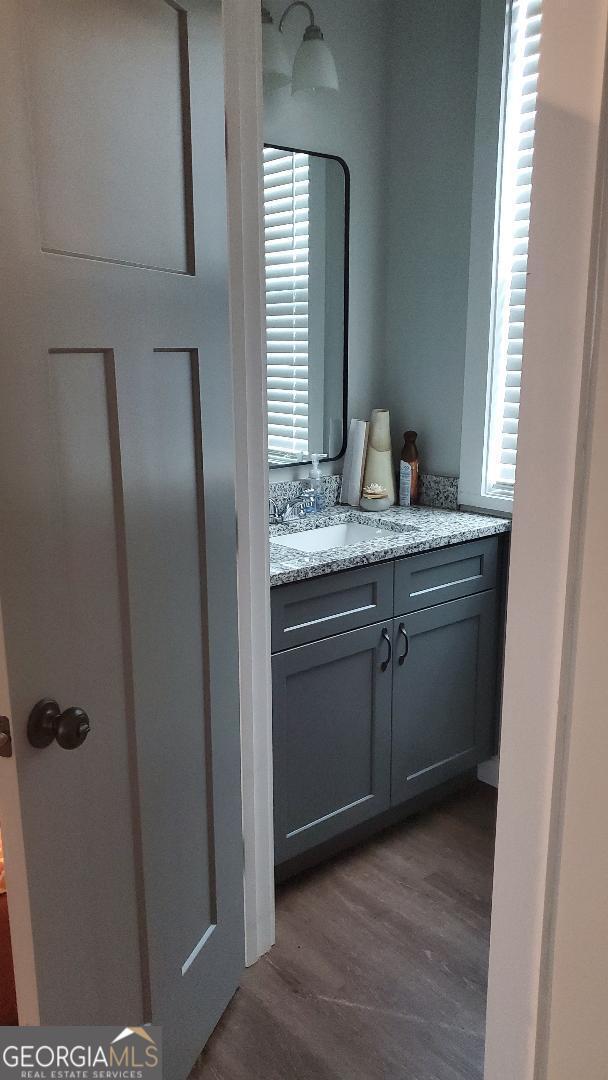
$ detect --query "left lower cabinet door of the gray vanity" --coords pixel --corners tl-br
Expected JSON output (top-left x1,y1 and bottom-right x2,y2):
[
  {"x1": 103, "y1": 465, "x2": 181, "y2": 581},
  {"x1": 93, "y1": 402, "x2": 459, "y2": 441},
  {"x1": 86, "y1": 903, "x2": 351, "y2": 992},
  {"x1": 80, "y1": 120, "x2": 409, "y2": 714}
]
[{"x1": 272, "y1": 620, "x2": 393, "y2": 863}]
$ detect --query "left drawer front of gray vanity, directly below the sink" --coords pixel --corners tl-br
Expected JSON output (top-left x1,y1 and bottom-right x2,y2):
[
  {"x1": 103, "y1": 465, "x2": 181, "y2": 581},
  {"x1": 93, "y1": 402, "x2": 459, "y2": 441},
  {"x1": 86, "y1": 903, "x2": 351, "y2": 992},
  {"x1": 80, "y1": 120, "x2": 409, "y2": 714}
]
[{"x1": 270, "y1": 563, "x2": 393, "y2": 652}]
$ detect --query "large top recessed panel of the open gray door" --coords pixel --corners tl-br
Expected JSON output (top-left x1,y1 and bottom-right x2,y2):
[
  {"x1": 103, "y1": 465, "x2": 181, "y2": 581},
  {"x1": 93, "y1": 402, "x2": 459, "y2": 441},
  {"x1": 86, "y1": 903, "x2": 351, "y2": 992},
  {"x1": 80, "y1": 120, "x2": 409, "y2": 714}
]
[{"x1": 22, "y1": 0, "x2": 194, "y2": 274}]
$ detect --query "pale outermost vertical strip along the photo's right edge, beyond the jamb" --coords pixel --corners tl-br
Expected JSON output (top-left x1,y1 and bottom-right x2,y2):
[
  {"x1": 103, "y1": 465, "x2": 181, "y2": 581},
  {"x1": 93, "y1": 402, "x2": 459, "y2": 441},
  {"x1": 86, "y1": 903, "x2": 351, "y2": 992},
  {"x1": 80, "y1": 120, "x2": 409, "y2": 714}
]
[{"x1": 538, "y1": 67, "x2": 608, "y2": 1080}]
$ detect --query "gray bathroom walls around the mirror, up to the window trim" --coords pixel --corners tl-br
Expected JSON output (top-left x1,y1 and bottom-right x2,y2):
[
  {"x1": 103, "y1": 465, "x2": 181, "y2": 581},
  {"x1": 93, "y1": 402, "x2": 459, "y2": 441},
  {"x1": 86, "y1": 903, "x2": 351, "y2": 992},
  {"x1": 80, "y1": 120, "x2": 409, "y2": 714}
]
[{"x1": 265, "y1": 0, "x2": 503, "y2": 480}]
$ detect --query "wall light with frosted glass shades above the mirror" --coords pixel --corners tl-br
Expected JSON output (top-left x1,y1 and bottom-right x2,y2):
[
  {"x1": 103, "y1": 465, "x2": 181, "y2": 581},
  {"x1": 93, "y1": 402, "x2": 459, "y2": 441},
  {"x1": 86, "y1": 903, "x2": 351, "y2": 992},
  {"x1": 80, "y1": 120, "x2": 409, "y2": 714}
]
[{"x1": 261, "y1": 0, "x2": 338, "y2": 94}]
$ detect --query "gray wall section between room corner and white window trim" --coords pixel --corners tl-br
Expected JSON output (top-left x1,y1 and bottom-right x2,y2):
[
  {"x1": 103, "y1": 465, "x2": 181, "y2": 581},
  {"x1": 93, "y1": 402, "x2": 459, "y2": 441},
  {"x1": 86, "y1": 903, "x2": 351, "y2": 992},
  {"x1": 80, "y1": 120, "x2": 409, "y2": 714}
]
[{"x1": 383, "y1": 0, "x2": 479, "y2": 476}]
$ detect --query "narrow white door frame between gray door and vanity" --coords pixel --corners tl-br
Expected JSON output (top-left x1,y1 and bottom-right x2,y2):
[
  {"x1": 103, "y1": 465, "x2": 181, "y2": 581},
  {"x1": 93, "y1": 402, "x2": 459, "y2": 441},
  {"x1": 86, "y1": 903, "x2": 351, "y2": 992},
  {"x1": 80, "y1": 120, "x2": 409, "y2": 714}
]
[{"x1": 224, "y1": 0, "x2": 274, "y2": 964}]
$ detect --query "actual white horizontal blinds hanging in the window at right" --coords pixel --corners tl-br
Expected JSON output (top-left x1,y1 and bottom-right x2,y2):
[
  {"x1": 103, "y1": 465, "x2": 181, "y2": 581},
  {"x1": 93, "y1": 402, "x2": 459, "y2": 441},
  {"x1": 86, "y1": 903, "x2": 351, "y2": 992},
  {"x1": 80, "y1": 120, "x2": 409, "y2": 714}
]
[{"x1": 486, "y1": 0, "x2": 542, "y2": 494}]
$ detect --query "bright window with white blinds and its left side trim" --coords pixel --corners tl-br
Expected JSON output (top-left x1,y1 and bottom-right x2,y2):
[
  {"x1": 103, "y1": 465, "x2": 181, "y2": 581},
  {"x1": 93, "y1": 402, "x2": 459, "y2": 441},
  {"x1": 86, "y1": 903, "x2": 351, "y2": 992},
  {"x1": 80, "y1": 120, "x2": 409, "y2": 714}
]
[{"x1": 460, "y1": 0, "x2": 542, "y2": 510}]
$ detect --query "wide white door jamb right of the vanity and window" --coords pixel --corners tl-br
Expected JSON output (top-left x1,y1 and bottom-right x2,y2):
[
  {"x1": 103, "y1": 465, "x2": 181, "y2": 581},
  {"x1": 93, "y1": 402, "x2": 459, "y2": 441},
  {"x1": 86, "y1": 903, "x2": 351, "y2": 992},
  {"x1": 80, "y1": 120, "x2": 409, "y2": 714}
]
[{"x1": 485, "y1": 0, "x2": 608, "y2": 1080}]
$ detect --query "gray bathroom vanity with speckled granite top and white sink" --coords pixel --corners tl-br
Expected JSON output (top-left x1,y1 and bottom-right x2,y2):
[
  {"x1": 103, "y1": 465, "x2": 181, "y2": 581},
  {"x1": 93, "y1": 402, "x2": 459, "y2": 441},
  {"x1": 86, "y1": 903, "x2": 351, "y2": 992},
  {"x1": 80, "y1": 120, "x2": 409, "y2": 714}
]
[{"x1": 271, "y1": 508, "x2": 509, "y2": 873}]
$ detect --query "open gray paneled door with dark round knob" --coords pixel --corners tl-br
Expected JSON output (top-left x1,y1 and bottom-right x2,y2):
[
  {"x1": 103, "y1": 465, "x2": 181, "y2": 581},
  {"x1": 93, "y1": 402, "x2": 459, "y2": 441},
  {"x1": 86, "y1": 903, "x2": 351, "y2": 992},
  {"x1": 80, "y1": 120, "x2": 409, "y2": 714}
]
[{"x1": 0, "y1": 0, "x2": 244, "y2": 1080}]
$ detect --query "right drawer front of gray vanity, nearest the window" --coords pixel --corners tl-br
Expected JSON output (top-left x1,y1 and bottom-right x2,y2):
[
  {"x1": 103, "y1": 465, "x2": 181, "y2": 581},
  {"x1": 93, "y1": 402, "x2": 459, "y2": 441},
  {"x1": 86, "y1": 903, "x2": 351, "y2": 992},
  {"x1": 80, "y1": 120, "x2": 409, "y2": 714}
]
[{"x1": 395, "y1": 537, "x2": 498, "y2": 616}]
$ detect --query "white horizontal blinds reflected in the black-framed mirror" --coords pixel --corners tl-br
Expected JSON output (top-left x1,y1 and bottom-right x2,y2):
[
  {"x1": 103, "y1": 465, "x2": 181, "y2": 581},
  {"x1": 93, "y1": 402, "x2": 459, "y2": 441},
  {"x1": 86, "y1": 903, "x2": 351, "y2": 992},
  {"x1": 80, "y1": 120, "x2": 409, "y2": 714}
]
[{"x1": 264, "y1": 147, "x2": 309, "y2": 456}]
